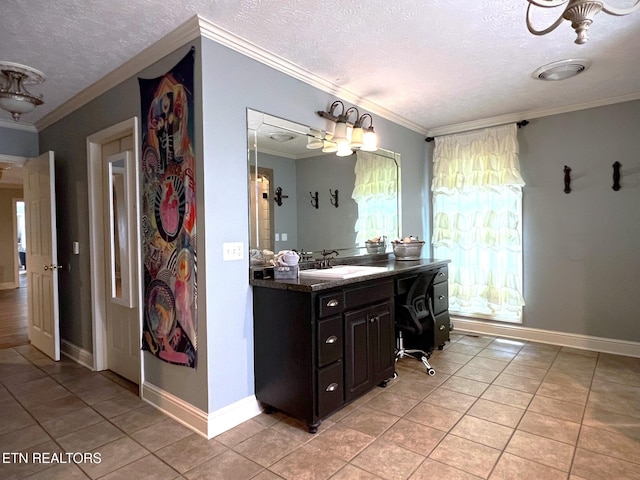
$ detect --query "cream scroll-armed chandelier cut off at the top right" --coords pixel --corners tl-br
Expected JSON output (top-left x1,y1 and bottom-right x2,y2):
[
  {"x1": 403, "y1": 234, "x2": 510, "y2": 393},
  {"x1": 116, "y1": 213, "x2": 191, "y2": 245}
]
[{"x1": 527, "y1": 0, "x2": 640, "y2": 45}]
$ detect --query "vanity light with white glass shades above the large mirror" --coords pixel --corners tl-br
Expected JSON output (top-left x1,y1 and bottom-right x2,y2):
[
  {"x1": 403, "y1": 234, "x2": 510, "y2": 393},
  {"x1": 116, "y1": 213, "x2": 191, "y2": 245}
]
[{"x1": 307, "y1": 100, "x2": 378, "y2": 157}]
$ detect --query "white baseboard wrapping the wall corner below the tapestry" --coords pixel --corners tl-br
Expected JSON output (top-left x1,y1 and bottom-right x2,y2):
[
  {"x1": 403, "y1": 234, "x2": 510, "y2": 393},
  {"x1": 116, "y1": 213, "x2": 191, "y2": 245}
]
[{"x1": 140, "y1": 382, "x2": 261, "y2": 439}]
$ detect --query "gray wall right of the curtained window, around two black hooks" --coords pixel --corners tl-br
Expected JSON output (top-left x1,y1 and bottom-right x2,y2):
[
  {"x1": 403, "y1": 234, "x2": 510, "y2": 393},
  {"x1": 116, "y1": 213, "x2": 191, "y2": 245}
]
[{"x1": 428, "y1": 101, "x2": 640, "y2": 342}]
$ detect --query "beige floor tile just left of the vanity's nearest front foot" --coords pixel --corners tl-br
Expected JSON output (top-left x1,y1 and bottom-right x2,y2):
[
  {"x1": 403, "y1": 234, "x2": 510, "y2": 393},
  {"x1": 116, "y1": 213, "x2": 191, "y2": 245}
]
[{"x1": 234, "y1": 428, "x2": 302, "y2": 466}]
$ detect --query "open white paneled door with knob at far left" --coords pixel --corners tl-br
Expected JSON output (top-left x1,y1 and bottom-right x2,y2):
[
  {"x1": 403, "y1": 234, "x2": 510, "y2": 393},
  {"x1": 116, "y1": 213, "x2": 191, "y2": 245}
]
[{"x1": 24, "y1": 152, "x2": 60, "y2": 360}]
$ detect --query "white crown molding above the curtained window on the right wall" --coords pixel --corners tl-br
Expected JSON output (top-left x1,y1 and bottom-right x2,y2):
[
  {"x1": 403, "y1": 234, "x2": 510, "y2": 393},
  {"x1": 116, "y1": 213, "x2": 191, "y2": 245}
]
[{"x1": 428, "y1": 92, "x2": 640, "y2": 137}]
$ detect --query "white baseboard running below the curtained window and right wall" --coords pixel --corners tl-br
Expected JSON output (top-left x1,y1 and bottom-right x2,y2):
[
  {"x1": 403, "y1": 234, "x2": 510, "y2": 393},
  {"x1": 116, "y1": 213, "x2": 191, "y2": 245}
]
[{"x1": 451, "y1": 316, "x2": 640, "y2": 358}]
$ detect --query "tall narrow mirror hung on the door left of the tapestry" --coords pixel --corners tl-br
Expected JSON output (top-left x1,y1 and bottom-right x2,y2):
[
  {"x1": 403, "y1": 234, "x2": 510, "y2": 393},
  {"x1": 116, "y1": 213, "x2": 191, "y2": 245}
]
[{"x1": 106, "y1": 152, "x2": 135, "y2": 308}]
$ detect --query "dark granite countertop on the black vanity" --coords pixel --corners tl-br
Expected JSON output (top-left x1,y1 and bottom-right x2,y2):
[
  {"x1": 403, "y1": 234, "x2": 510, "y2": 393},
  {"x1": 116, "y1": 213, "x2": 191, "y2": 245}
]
[{"x1": 249, "y1": 258, "x2": 450, "y2": 292}]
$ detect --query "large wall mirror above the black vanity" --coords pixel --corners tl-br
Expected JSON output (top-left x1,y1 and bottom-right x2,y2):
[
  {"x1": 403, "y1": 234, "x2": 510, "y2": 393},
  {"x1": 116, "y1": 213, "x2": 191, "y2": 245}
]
[{"x1": 247, "y1": 109, "x2": 401, "y2": 254}]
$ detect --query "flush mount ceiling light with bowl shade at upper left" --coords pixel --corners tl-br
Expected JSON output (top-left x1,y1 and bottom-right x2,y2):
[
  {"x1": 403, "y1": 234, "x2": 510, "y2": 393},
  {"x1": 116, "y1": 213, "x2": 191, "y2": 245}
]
[{"x1": 0, "y1": 62, "x2": 46, "y2": 122}]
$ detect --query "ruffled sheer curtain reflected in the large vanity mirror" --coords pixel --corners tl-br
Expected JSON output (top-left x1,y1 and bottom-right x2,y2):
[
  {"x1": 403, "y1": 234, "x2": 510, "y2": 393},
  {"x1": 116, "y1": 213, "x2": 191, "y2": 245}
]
[{"x1": 351, "y1": 151, "x2": 398, "y2": 246}]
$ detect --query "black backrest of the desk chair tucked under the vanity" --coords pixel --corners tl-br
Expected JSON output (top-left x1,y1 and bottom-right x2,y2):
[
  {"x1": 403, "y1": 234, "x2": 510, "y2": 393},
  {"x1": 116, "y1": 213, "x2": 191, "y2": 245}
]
[{"x1": 396, "y1": 272, "x2": 435, "y2": 335}]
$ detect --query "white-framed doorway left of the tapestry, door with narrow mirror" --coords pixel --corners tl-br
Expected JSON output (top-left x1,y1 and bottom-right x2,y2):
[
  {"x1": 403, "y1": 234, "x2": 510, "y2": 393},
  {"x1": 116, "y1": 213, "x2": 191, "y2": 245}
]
[{"x1": 87, "y1": 117, "x2": 142, "y2": 385}]
